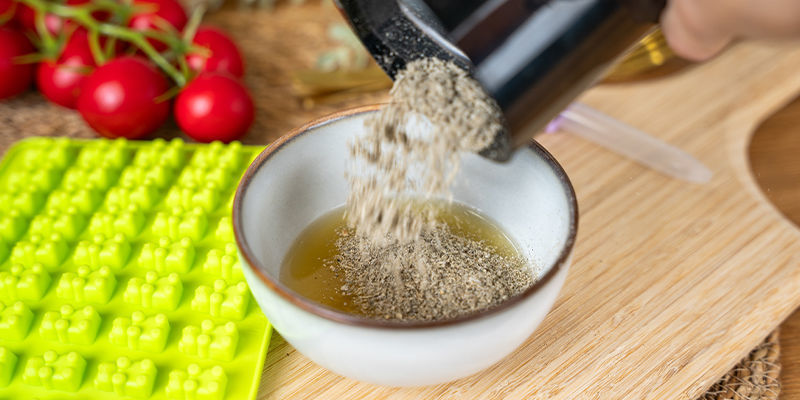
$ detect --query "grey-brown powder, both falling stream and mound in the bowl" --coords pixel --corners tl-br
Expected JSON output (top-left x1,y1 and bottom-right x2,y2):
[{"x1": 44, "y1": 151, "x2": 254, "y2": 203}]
[{"x1": 328, "y1": 59, "x2": 534, "y2": 320}]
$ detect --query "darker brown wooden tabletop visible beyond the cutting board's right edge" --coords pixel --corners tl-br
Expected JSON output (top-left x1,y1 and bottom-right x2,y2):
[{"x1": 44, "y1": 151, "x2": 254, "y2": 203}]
[{"x1": 749, "y1": 98, "x2": 800, "y2": 400}]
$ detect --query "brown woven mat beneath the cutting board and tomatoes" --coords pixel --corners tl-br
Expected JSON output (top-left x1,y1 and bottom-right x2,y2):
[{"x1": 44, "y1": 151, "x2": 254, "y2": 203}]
[{"x1": 0, "y1": 5, "x2": 780, "y2": 400}]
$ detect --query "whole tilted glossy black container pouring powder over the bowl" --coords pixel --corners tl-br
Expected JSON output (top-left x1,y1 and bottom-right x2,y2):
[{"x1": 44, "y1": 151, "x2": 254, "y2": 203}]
[{"x1": 337, "y1": 0, "x2": 665, "y2": 160}]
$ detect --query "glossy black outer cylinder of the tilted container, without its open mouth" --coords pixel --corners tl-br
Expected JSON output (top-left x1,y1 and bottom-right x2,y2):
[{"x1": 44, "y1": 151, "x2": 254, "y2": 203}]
[{"x1": 418, "y1": 0, "x2": 663, "y2": 146}]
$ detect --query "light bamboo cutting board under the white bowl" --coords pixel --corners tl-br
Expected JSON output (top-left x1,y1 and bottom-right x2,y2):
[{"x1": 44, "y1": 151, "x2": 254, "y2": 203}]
[{"x1": 242, "y1": 15, "x2": 800, "y2": 399}]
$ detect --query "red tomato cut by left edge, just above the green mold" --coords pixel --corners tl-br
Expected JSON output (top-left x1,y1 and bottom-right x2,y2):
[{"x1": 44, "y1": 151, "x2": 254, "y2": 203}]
[{"x1": 0, "y1": 26, "x2": 34, "y2": 99}]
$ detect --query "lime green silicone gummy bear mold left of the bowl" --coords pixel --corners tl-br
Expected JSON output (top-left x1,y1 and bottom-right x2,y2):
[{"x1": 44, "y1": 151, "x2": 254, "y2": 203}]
[{"x1": 0, "y1": 138, "x2": 271, "y2": 400}]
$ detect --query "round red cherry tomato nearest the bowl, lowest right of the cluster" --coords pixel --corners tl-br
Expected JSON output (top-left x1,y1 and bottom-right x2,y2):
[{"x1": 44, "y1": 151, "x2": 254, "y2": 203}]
[{"x1": 175, "y1": 73, "x2": 253, "y2": 142}]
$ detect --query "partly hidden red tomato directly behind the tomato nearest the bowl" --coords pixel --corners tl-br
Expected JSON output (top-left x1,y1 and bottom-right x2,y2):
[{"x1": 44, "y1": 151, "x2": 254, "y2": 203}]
[{"x1": 186, "y1": 26, "x2": 244, "y2": 78}]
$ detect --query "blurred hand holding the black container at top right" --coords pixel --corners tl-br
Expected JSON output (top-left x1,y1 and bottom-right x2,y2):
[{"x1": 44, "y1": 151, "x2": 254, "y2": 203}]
[{"x1": 661, "y1": 0, "x2": 800, "y2": 61}]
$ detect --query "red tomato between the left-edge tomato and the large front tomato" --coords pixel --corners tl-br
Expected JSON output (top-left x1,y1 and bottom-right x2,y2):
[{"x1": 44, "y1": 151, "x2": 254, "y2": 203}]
[{"x1": 36, "y1": 30, "x2": 96, "y2": 108}]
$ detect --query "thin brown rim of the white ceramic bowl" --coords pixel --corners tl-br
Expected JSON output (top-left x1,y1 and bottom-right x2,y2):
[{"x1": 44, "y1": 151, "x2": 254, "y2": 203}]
[{"x1": 232, "y1": 104, "x2": 578, "y2": 329}]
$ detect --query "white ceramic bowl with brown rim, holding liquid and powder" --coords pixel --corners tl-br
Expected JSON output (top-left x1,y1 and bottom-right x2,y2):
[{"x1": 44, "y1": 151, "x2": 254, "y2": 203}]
[{"x1": 233, "y1": 107, "x2": 578, "y2": 386}]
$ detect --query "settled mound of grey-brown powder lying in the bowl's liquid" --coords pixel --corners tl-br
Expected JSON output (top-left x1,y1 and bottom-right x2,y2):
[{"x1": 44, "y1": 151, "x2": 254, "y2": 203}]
[{"x1": 331, "y1": 225, "x2": 533, "y2": 321}]
